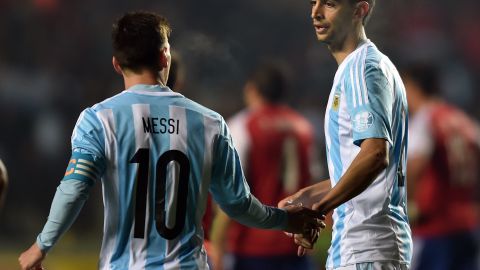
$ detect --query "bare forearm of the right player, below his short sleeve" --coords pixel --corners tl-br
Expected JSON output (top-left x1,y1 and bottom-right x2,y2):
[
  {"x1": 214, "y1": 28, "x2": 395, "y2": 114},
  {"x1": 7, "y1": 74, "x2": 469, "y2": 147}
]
[{"x1": 315, "y1": 142, "x2": 388, "y2": 214}]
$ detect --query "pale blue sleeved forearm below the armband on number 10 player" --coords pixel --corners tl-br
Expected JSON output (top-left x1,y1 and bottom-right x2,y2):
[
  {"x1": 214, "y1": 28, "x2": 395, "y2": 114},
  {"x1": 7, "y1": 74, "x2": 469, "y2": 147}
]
[{"x1": 37, "y1": 180, "x2": 90, "y2": 252}]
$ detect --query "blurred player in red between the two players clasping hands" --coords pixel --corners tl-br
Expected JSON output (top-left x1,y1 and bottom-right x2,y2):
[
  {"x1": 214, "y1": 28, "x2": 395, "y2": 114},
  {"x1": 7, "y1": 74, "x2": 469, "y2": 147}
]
[{"x1": 211, "y1": 64, "x2": 315, "y2": 270}]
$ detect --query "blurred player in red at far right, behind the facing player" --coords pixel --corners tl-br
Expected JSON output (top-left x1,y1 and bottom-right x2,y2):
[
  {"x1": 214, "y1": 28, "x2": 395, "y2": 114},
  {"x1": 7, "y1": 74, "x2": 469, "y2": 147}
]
[{"x1": 402, "y1": 63, "x2": 480, "y2": 270}]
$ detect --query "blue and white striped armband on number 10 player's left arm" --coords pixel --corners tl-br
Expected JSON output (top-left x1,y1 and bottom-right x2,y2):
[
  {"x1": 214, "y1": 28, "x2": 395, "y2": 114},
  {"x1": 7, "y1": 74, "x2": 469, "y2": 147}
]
[{"x1": 62, "y1": 152, "x2": 100, "y2": 185}]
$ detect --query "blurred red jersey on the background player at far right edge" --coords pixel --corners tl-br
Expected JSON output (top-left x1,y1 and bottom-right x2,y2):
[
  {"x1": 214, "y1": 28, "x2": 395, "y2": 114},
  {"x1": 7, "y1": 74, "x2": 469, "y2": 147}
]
[{"x1": 409, "y1": 103, "x2": 480, "y2": 236}]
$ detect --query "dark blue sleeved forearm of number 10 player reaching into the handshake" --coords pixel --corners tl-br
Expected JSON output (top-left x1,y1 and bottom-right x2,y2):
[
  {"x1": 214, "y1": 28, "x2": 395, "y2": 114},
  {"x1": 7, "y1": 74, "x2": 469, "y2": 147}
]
[{"x1": 219, "y1": 195, "x2": 287, "y2": 230}]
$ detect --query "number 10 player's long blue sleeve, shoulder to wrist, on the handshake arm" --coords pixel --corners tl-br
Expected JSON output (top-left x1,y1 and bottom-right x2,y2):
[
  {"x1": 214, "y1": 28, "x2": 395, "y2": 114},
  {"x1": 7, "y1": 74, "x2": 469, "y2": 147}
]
[{"x1": 210, "y1": 120, "x2": 287, "y2": 229}]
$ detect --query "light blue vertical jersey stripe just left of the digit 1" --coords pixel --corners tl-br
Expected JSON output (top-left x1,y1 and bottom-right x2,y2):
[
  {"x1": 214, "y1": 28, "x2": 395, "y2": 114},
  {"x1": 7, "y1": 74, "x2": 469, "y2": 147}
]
[{"x1": 112, "y1": 102, "x2": 136, "y2": 268}]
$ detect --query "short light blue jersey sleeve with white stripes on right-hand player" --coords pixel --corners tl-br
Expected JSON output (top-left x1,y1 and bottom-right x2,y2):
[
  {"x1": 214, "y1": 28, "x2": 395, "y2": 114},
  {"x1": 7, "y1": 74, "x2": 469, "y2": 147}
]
[{"x1": 347, "y1": 64, "x2": 393, "y2": 146}]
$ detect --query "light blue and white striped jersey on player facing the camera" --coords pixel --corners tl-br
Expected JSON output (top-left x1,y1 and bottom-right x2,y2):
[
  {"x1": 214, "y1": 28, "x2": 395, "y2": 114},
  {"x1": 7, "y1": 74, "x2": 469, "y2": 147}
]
[{"x1": 325, "y1": 40, "x2": 412, "y2": 269}]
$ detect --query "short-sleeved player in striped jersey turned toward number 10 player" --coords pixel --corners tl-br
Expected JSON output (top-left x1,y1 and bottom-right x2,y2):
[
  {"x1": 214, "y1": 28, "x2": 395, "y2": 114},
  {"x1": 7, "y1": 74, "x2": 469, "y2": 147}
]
[{"x1": 279, "y1": 0, "x2": 412, "y2": 270}]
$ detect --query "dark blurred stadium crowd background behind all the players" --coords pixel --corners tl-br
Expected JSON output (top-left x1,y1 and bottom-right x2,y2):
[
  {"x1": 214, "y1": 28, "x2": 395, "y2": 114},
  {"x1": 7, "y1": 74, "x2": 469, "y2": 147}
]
[{"x1": 0, "y1": 0, "x2": 480, "y2": 270}]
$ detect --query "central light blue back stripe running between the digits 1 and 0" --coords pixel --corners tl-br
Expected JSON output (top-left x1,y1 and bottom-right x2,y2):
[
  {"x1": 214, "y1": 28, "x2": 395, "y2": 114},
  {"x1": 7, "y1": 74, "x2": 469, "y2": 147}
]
[{"x1": 145, "y1": 100, "x2": 170, "y2": 270}]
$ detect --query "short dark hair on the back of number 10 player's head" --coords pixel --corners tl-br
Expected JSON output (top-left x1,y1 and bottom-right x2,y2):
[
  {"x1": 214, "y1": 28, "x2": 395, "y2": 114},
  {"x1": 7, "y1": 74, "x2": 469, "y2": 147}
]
[{"x1": 112, "y1": 11, "x2": 171, "y2": 72}]
